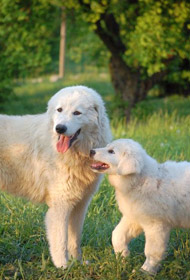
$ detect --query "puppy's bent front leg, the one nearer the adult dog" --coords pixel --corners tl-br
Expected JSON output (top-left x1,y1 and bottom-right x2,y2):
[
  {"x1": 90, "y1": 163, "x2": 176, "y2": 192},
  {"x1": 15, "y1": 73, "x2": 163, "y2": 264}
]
[{"x1": 112, "y1": 216, "x2": 142, "y2": 257}]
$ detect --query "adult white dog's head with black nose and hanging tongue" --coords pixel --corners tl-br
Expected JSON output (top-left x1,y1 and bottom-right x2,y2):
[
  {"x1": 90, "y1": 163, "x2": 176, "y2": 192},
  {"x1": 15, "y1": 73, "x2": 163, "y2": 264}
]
[{"x1": 48, "y1": 86, "x2": 109, "y2": 154}]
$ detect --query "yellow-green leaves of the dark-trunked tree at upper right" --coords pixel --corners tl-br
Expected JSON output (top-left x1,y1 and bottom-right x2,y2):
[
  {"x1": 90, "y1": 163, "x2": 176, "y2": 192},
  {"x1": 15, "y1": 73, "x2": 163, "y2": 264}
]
[{"x1": 64, "y1": 0, "x2": 190, "y2": 76}]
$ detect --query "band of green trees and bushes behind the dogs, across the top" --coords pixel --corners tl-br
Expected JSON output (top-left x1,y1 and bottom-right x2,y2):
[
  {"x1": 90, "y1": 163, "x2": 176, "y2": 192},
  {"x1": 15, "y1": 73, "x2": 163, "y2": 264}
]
[{"x1": 0, "y1": 0, "x2": 190, "y2": 119}]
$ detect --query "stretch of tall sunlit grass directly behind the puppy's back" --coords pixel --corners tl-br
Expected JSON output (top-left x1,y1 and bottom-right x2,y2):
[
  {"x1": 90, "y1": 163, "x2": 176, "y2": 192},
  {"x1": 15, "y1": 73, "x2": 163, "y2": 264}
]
[{"x1": 112, "y1": 110, "x2": 190, "y2": 162}]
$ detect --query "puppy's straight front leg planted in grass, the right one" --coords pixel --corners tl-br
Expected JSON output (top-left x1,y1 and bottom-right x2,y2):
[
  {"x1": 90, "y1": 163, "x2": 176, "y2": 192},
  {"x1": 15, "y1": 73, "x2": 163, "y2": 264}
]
[{"x1": 142, "y1": 223, "x2": 170, "y2": 274}]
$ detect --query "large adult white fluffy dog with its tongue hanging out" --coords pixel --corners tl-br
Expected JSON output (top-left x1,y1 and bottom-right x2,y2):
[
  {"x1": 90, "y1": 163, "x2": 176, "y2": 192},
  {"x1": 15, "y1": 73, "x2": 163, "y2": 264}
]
[{"x1": 0, "y1": 86, "x2": 111, "y2": 268}]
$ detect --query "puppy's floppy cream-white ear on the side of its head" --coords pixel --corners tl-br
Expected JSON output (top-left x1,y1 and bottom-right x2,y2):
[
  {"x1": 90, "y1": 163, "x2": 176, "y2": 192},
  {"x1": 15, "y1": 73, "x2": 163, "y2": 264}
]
[{"x1": 117, "y1": 153, "x2": 143, "y2": 175}]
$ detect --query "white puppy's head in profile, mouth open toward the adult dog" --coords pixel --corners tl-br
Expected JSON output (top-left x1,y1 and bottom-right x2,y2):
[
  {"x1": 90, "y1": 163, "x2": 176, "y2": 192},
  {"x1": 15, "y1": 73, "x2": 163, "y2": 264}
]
[{"x1": 90, "y1": 139, "x2": 145, "y2": 176}]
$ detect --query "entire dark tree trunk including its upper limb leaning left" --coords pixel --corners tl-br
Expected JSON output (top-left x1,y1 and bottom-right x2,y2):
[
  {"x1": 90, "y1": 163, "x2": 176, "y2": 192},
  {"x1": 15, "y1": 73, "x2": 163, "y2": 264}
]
[{"x1": 79, "y1": 4, "x2": 166, "y2": 120}]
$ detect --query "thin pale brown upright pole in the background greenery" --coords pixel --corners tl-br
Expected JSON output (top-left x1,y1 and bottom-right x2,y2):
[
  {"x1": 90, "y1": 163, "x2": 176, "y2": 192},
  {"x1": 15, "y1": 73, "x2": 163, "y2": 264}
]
[{"x1": 59, "y1": 7, "x2": 66, "y2": 79}]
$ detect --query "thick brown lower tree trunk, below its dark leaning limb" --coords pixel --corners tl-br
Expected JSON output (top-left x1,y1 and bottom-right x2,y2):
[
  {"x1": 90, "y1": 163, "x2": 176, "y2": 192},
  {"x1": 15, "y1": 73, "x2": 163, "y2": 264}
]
[{"x1": 110, "y1": 54, "x2": 165, "y2": 121}]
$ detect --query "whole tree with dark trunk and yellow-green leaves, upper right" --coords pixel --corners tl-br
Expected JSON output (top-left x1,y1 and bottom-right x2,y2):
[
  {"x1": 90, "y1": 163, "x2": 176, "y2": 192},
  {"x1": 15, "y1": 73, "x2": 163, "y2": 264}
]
[{"x1": 64, "y1": 0, "x2": 190, "y2": 118}]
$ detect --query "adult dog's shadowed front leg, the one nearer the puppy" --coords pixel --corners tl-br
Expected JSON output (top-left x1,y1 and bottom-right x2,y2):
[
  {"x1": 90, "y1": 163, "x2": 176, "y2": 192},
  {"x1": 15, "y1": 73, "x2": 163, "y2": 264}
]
[{"x1": 68, "y1": 192, "x2": 92, "y2": 260}]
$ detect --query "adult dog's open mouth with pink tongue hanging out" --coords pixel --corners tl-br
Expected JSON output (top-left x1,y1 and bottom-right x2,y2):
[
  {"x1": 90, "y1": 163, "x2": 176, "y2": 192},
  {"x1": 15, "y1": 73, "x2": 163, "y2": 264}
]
[{"x1": 57, "y1": 129, "x2": 81, "y2": 154}]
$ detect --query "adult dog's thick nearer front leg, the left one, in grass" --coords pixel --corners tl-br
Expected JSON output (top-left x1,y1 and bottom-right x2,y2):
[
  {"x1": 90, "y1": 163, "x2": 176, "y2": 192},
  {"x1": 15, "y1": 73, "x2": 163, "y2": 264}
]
[{"x1": 45, "y1": 205, "x2": 70, "y2": 268}]
